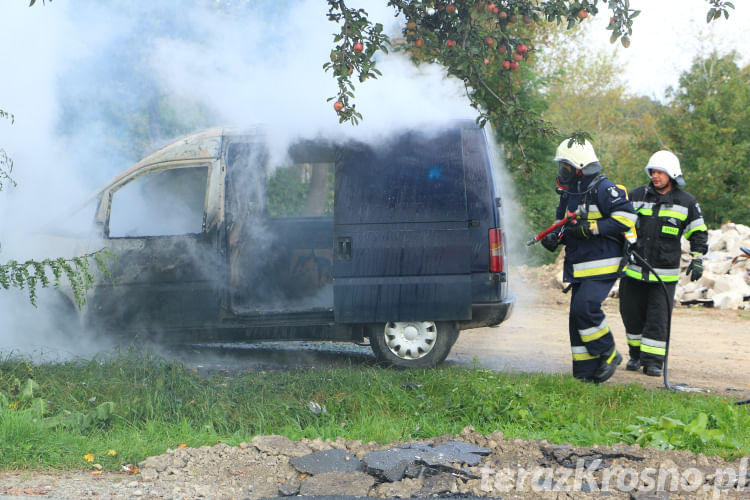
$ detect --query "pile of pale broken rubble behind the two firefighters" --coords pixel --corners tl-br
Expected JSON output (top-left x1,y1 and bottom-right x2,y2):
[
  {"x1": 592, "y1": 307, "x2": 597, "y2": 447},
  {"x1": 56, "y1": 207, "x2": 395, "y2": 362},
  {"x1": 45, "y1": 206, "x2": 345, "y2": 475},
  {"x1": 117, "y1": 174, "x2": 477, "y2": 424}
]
[{"x1": 520, "y1": 222, "x2": 750, "y2": 309}]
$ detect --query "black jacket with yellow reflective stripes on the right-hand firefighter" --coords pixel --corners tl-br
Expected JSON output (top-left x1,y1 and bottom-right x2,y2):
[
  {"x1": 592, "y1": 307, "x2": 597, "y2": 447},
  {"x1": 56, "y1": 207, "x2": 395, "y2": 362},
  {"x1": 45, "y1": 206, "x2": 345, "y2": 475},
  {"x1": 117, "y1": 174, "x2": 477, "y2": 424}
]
[{"x1": 625, "y1": 182, "x2": 708, "y2": 282}]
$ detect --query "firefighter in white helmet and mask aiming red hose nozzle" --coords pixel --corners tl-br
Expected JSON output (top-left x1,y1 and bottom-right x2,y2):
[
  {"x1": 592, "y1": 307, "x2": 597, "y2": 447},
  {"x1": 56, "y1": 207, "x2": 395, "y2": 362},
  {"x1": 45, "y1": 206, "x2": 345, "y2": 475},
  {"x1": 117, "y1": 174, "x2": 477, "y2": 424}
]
[{"x1": 542, "y1": 139, "x2": 636, "y2": 383}]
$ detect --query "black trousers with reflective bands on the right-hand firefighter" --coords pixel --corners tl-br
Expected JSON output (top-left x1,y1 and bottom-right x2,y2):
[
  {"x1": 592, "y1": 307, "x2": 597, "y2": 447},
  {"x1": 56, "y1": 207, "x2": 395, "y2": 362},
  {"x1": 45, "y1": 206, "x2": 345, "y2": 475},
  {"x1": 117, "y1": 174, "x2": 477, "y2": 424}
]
[{"x1": 620, "y1": 277, "x2": 677, "y2": 368}]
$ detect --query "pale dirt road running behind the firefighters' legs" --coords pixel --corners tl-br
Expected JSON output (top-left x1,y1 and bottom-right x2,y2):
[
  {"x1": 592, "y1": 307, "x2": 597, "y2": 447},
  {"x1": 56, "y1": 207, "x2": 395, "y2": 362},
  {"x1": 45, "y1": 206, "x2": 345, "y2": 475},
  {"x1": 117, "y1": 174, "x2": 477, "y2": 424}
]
[{"x1": 448, "y1": 277, "x2": 750, "y2": 399}]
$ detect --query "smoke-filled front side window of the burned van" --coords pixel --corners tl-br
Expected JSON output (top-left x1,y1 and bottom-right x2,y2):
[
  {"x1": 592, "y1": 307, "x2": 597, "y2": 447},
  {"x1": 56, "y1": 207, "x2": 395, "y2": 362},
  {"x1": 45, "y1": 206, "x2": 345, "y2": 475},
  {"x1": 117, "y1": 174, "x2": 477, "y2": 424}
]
[{"x1": 108, "y1": 166, "x2": 208, "y2": 238}]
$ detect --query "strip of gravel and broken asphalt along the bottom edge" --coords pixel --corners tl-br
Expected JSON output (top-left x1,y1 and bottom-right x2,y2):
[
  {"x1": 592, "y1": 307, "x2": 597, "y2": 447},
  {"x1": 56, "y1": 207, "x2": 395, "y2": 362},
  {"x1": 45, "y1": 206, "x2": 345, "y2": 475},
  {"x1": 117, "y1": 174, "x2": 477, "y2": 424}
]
[{"x1": 0, "y1": 427, "x2": 750, "y2": 500}]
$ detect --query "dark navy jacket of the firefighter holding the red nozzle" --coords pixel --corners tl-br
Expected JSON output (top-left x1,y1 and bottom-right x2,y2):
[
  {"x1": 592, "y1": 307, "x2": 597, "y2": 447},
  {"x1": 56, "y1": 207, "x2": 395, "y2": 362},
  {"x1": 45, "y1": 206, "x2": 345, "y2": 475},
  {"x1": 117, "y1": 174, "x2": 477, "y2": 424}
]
[{"x1": 557, "y1": 173, "x2": 636, "y2": 283}]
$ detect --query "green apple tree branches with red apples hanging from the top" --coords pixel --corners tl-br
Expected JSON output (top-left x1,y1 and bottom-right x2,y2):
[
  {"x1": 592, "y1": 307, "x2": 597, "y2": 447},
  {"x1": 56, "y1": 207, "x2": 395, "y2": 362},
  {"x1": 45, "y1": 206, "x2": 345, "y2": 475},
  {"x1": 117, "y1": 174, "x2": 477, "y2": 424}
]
[{"x1": 324, "y1": 0, "x2": 734, "y2": 168}]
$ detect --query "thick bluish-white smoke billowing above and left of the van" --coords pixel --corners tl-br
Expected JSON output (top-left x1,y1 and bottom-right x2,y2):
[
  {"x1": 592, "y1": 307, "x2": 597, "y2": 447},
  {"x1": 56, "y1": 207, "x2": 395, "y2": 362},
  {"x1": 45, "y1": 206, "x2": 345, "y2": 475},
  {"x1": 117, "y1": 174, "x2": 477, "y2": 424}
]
[{"x1": 0, "y1": 0, "x2": 516, "y2": 355}]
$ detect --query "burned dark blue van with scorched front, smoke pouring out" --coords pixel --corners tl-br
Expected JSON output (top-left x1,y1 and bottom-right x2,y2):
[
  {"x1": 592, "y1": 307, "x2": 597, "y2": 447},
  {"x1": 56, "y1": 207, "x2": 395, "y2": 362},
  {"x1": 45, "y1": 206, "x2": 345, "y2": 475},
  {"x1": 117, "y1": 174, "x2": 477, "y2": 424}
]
[{"x1": 84, "y1": 122, "x2": 512, "y2": 367}]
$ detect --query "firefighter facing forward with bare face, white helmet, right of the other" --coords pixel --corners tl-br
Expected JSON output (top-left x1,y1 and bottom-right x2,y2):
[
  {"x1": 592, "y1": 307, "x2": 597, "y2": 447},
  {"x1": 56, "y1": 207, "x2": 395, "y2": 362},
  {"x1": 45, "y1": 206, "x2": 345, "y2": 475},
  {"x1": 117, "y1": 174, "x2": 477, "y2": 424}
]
[{"x1": 619, "y1": 151, "x2": 708, "y2": 377}]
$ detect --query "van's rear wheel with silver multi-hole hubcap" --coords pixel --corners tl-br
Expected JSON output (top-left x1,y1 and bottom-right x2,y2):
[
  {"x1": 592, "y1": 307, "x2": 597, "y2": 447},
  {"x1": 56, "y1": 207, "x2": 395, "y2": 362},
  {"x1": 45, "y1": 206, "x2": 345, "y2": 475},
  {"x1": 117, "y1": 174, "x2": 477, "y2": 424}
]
[{"x1": 369, "y1": 321, "x2": 458, "y2": 368}]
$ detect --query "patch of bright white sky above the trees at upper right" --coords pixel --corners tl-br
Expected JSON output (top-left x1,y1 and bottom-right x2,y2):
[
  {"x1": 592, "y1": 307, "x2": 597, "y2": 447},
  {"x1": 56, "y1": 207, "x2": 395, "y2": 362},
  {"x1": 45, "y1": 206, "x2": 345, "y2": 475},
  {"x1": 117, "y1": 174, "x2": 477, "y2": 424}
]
[{"x1": 587, "y1": 0, "x2": 750, "y2": 100}]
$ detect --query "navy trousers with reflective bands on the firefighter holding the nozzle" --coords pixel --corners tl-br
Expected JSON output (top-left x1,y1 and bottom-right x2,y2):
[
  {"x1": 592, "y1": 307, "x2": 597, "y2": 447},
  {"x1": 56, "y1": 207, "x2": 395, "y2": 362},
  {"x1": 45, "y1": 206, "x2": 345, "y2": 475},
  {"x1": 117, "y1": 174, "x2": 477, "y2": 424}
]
[{"x1": 568, "y1": 278, "x2": 616, "y2": 380}]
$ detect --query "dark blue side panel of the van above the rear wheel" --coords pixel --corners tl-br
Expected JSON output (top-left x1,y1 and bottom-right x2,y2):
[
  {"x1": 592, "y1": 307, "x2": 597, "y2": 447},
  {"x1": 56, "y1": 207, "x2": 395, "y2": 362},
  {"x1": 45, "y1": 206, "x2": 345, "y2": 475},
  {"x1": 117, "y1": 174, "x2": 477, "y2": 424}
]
[{"x1": 334, "y1": 129, "x2": 471, "y2": 323}]
